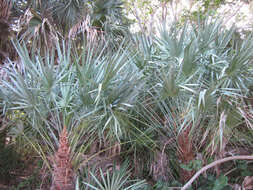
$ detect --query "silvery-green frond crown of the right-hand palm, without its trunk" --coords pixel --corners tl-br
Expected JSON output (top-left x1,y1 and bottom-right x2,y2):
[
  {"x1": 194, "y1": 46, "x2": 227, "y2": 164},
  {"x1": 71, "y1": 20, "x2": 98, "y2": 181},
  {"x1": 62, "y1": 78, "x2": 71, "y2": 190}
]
[{"x1": 137, "y1": 19, "x2": 253, "y2": 157}]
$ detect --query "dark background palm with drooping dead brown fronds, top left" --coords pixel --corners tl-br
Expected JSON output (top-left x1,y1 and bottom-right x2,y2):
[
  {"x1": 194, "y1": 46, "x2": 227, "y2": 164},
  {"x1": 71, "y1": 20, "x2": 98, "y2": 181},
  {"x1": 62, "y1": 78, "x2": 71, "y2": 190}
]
[{"x1": 14, "y1": 0, "x2": 128, "y2": 50}]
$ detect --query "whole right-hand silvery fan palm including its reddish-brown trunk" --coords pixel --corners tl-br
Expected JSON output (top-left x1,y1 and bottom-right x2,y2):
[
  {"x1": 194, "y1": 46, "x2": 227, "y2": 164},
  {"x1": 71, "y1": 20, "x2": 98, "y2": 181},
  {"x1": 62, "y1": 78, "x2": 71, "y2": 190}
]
[{"x1": 136, "y1": 19, "x2": 253, "y2": 182}]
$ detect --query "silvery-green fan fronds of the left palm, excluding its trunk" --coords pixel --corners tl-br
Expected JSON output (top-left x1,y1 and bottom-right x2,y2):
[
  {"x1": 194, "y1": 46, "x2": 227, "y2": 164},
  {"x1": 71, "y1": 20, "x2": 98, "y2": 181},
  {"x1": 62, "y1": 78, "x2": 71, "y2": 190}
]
[{"x1": 1, "y1": 36, "x2": 147, "y2": 187}]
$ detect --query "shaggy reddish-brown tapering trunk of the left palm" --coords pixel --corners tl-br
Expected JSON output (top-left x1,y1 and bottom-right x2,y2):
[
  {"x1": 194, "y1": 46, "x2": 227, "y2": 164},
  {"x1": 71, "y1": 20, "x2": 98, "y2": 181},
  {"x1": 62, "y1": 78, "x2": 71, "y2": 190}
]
[{"x1": 51, "y1": 126, "x2": 75, "y2": 190}]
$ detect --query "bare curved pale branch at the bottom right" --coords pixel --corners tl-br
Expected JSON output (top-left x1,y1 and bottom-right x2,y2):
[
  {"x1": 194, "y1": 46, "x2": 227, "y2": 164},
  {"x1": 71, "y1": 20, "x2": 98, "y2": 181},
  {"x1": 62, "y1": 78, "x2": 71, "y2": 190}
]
[{"x1": 181, "y1": 155, "x2": 253, "y2": 190}]
